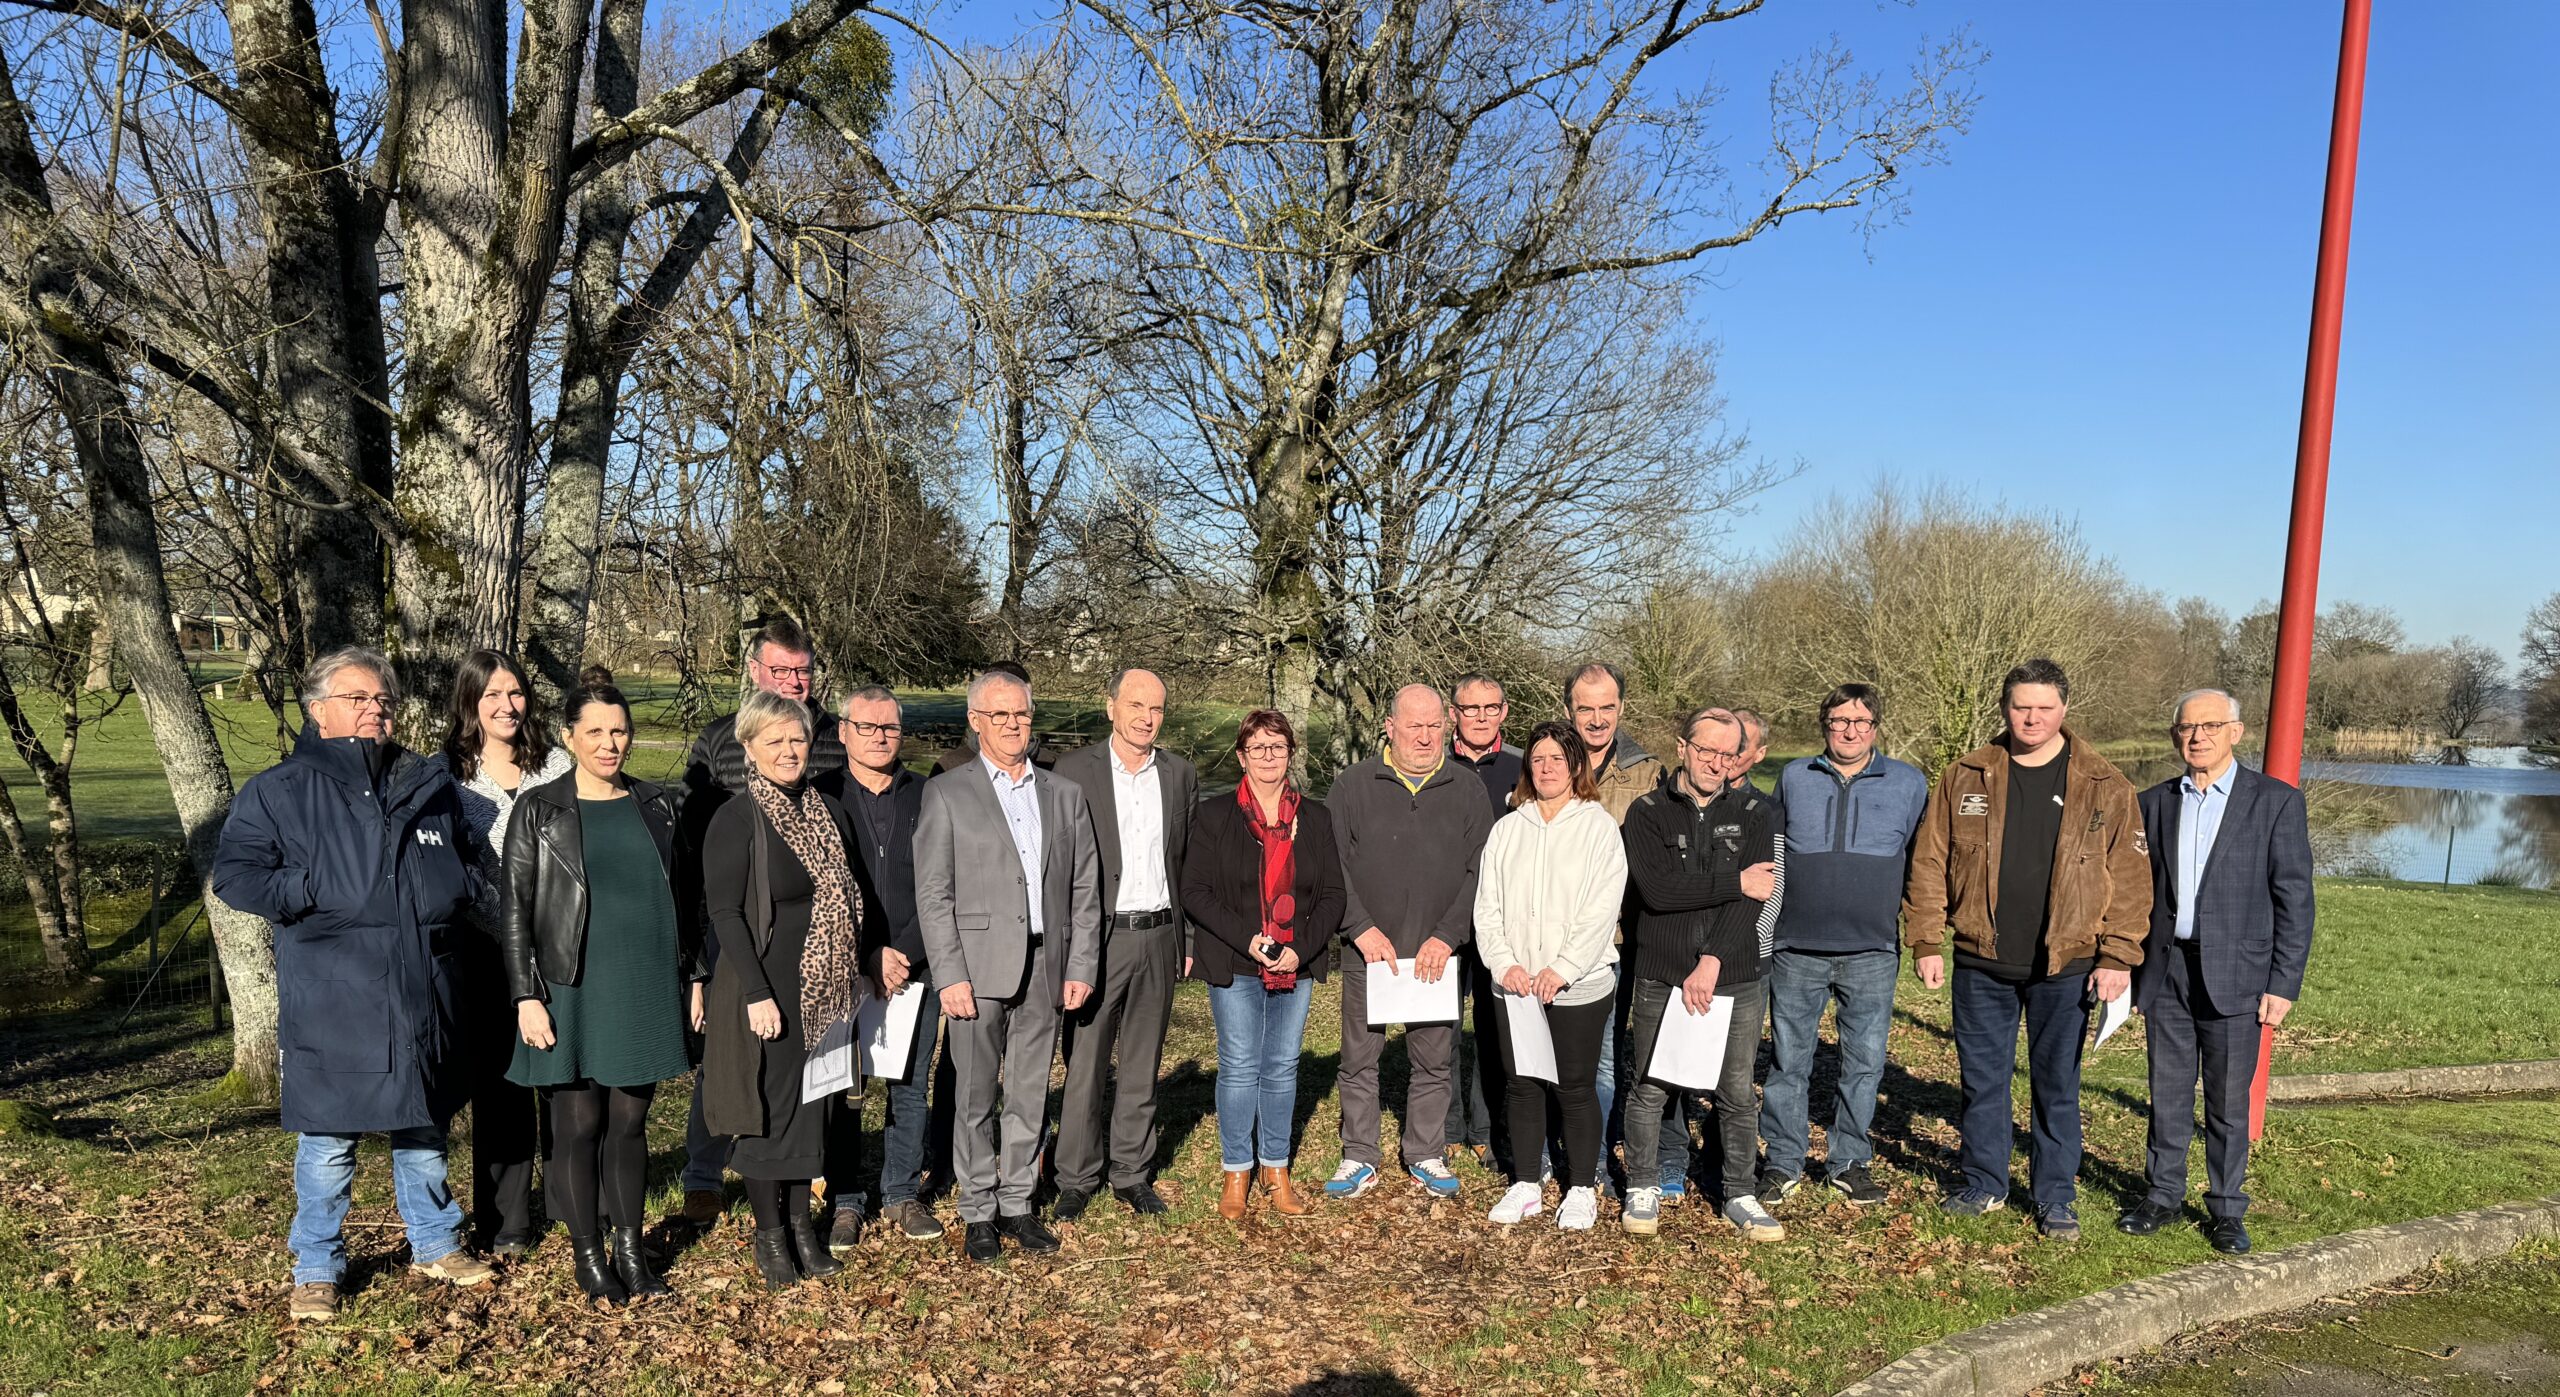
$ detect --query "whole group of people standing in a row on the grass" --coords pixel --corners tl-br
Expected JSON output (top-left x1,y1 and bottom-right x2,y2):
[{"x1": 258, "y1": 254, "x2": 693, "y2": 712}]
[{"x1": 215, "y1": 622, "x2": 2312, "y2": 1318}]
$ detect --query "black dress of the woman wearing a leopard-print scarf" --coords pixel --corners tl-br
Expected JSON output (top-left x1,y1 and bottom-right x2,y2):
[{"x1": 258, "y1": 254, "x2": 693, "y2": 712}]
[{"x1": 701, "y1": 798, "x2": 835, "y2": 1180}]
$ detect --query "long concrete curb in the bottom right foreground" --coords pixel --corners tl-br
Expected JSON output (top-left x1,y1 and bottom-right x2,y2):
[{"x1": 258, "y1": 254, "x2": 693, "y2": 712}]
[{"x1": 1838, "y1": 1195, "x2": 2560, "y2": 1397}]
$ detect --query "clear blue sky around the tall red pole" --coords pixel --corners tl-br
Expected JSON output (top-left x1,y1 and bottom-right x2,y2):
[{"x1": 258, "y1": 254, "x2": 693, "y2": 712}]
[{"x1": 870, "y1": 0, "x2": 2560, "y2": 655}]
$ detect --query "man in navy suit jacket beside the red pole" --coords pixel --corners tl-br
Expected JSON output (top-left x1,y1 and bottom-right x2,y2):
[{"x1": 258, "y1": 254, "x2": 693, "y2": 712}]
[{"x1": 2115, "y1": 688, "x2": 2312, "y2": 1256}]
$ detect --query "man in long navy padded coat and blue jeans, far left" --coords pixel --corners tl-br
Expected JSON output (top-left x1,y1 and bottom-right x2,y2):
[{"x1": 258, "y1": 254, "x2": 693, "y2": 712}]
[{"x1": 212, "y1": 647, "x2": 492, "y2": 1320}]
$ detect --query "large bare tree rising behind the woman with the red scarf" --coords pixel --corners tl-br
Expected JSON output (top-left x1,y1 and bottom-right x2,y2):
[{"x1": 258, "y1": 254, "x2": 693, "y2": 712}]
[{"x1": 988, "y1": 0, "x2": 1974, "y2": 755}]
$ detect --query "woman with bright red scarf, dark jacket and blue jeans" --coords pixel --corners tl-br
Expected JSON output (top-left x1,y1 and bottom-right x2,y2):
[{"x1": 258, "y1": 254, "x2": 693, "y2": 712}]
[{"x1": 1183, "y1": 709, "x2": 1341, "y2": 1220}]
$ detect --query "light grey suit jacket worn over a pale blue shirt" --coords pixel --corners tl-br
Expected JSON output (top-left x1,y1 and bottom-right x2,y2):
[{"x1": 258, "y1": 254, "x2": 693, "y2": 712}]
[{"x1": 916, "y1": 762, "x2": 1103, "y2": 1000}]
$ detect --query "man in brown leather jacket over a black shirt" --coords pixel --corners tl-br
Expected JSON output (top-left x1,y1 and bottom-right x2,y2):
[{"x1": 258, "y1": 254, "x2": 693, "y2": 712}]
[{"x1": 1902, "y1": 660, "x2": 2150, "y2": 1238}]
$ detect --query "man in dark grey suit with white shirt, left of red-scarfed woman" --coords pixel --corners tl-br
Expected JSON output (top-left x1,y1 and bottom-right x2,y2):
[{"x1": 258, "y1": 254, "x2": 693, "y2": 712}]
[{"x1": 1050, "y1": 670, "x2": 1201, "y2": 1223}]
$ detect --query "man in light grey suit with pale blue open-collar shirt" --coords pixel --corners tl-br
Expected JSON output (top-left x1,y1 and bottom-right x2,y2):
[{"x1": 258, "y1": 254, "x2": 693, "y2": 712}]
[{"x1": 916, "y1": 670, "x2": 1101, "y2": 1261}]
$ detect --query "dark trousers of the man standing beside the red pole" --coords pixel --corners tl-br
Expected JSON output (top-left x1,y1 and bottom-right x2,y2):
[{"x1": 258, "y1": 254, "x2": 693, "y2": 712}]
[{"x1": 2143, "y1": 942, "x2": 2258, "y2": 1218}]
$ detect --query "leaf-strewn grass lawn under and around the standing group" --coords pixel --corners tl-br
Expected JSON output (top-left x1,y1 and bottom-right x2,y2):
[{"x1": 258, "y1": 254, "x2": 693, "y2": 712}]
[{"x1": 0, "y1": 883, "x2": 2560, "y2": 1394}]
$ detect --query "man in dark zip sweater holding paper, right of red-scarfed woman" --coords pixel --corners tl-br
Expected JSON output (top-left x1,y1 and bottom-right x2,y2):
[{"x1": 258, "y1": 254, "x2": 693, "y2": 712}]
[{"x1": 1324, "y1": 683, "x2": 1492, "y2": 1197}]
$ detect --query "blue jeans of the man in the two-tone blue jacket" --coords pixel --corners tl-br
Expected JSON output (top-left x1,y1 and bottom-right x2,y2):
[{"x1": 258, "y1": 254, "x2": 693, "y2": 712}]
[{"x1": 1761, "y1": 952, "x2": 1902, "y2": 1177}]
